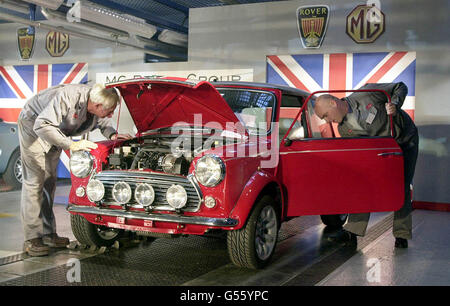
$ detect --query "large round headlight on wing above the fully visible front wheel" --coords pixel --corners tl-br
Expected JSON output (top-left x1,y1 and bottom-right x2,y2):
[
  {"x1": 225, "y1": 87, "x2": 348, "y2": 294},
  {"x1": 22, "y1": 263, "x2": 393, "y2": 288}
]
[{"x1": 195, "y1": 155, "x2": 225, "y2": 187}]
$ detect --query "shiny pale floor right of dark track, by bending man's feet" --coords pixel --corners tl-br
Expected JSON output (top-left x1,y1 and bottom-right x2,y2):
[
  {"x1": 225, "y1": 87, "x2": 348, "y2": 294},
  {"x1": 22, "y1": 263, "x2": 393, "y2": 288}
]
[{"x1": 317, "y1": 210, "x2": 450, "y2": 286}]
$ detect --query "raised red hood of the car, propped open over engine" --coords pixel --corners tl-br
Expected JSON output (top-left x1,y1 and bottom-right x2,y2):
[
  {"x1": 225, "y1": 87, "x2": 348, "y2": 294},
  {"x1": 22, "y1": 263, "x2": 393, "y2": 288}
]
[{"x1": 106, "y1": 78, "x2": 246, "y2": 134}]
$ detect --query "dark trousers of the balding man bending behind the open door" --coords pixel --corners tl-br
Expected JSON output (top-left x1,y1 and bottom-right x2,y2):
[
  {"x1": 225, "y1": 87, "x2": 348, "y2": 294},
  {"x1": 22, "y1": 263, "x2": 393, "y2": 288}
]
[{"x1": 344, "y1": 135, "x2": 419, "y2": 239}]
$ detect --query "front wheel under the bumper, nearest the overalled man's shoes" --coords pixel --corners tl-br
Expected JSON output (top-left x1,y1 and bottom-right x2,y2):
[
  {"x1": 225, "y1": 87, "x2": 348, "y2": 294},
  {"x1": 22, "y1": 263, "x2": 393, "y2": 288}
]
[{"x1": 70, "y1": 215, "x2": 122, "y2": 247}]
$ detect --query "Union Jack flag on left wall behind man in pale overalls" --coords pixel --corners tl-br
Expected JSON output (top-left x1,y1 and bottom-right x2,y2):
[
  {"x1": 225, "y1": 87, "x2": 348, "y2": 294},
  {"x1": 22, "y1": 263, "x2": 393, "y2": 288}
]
[{"x1": 0, "y1": 63, "x2": 88, "y2": 177}]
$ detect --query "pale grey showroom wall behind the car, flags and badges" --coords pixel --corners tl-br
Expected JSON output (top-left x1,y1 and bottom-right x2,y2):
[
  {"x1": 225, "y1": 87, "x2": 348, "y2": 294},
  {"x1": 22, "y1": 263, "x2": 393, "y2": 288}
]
[{"x1": 0, "y1": 0, "x2": 450, "y2": 208}]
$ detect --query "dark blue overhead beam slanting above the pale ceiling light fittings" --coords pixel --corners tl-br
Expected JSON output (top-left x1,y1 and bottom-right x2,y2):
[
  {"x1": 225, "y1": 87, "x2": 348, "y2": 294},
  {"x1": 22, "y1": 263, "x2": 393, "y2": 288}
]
[{"x1": 89, "y1": 0, "x2": 188, "y2": 34}]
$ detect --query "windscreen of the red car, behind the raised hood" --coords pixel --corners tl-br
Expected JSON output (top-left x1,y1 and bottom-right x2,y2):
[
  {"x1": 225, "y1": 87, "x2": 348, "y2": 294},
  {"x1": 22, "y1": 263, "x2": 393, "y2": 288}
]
[{"x1": 217, "y1": 88, "x2": 276, "y2": 135}]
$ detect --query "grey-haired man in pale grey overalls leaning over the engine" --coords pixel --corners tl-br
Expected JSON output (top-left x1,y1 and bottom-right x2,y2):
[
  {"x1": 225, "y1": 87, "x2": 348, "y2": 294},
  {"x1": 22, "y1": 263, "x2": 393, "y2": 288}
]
[{"x1": 18, "y1": 84, "x2": 129, "y2": 256}]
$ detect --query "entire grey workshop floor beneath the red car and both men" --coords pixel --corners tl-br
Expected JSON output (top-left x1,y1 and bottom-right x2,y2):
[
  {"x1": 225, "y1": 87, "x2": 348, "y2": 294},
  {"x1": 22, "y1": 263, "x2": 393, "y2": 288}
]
[{"x1": 0, "y1": 181, "x2": 450, "y2": 286}]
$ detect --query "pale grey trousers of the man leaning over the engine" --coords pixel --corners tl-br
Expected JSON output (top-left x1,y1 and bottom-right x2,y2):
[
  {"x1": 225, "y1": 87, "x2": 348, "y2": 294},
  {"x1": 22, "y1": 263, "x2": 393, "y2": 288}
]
[{"x1": 17, "y1": 114, "x2": 61, "y2": 240}]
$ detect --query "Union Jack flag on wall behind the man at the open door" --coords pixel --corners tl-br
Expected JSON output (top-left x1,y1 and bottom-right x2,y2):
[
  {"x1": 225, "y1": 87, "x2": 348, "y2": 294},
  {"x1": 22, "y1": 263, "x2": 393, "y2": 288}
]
[{"x1": 267, "y1": 52, "x2": 416, "y2": 119}]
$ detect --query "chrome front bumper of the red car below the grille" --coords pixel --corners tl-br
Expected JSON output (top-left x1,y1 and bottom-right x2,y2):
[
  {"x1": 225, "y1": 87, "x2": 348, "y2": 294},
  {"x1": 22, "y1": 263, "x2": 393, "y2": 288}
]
[{"x1": 67, "y1": 204, "x2": 238, "y2": 227}]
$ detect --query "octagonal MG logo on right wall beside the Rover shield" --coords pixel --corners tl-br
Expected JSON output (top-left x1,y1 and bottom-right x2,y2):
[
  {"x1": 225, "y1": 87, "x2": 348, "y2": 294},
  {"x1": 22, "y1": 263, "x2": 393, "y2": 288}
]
[{"x1": 346, "y1": 5, "x2": 385, "y2": 44}]
